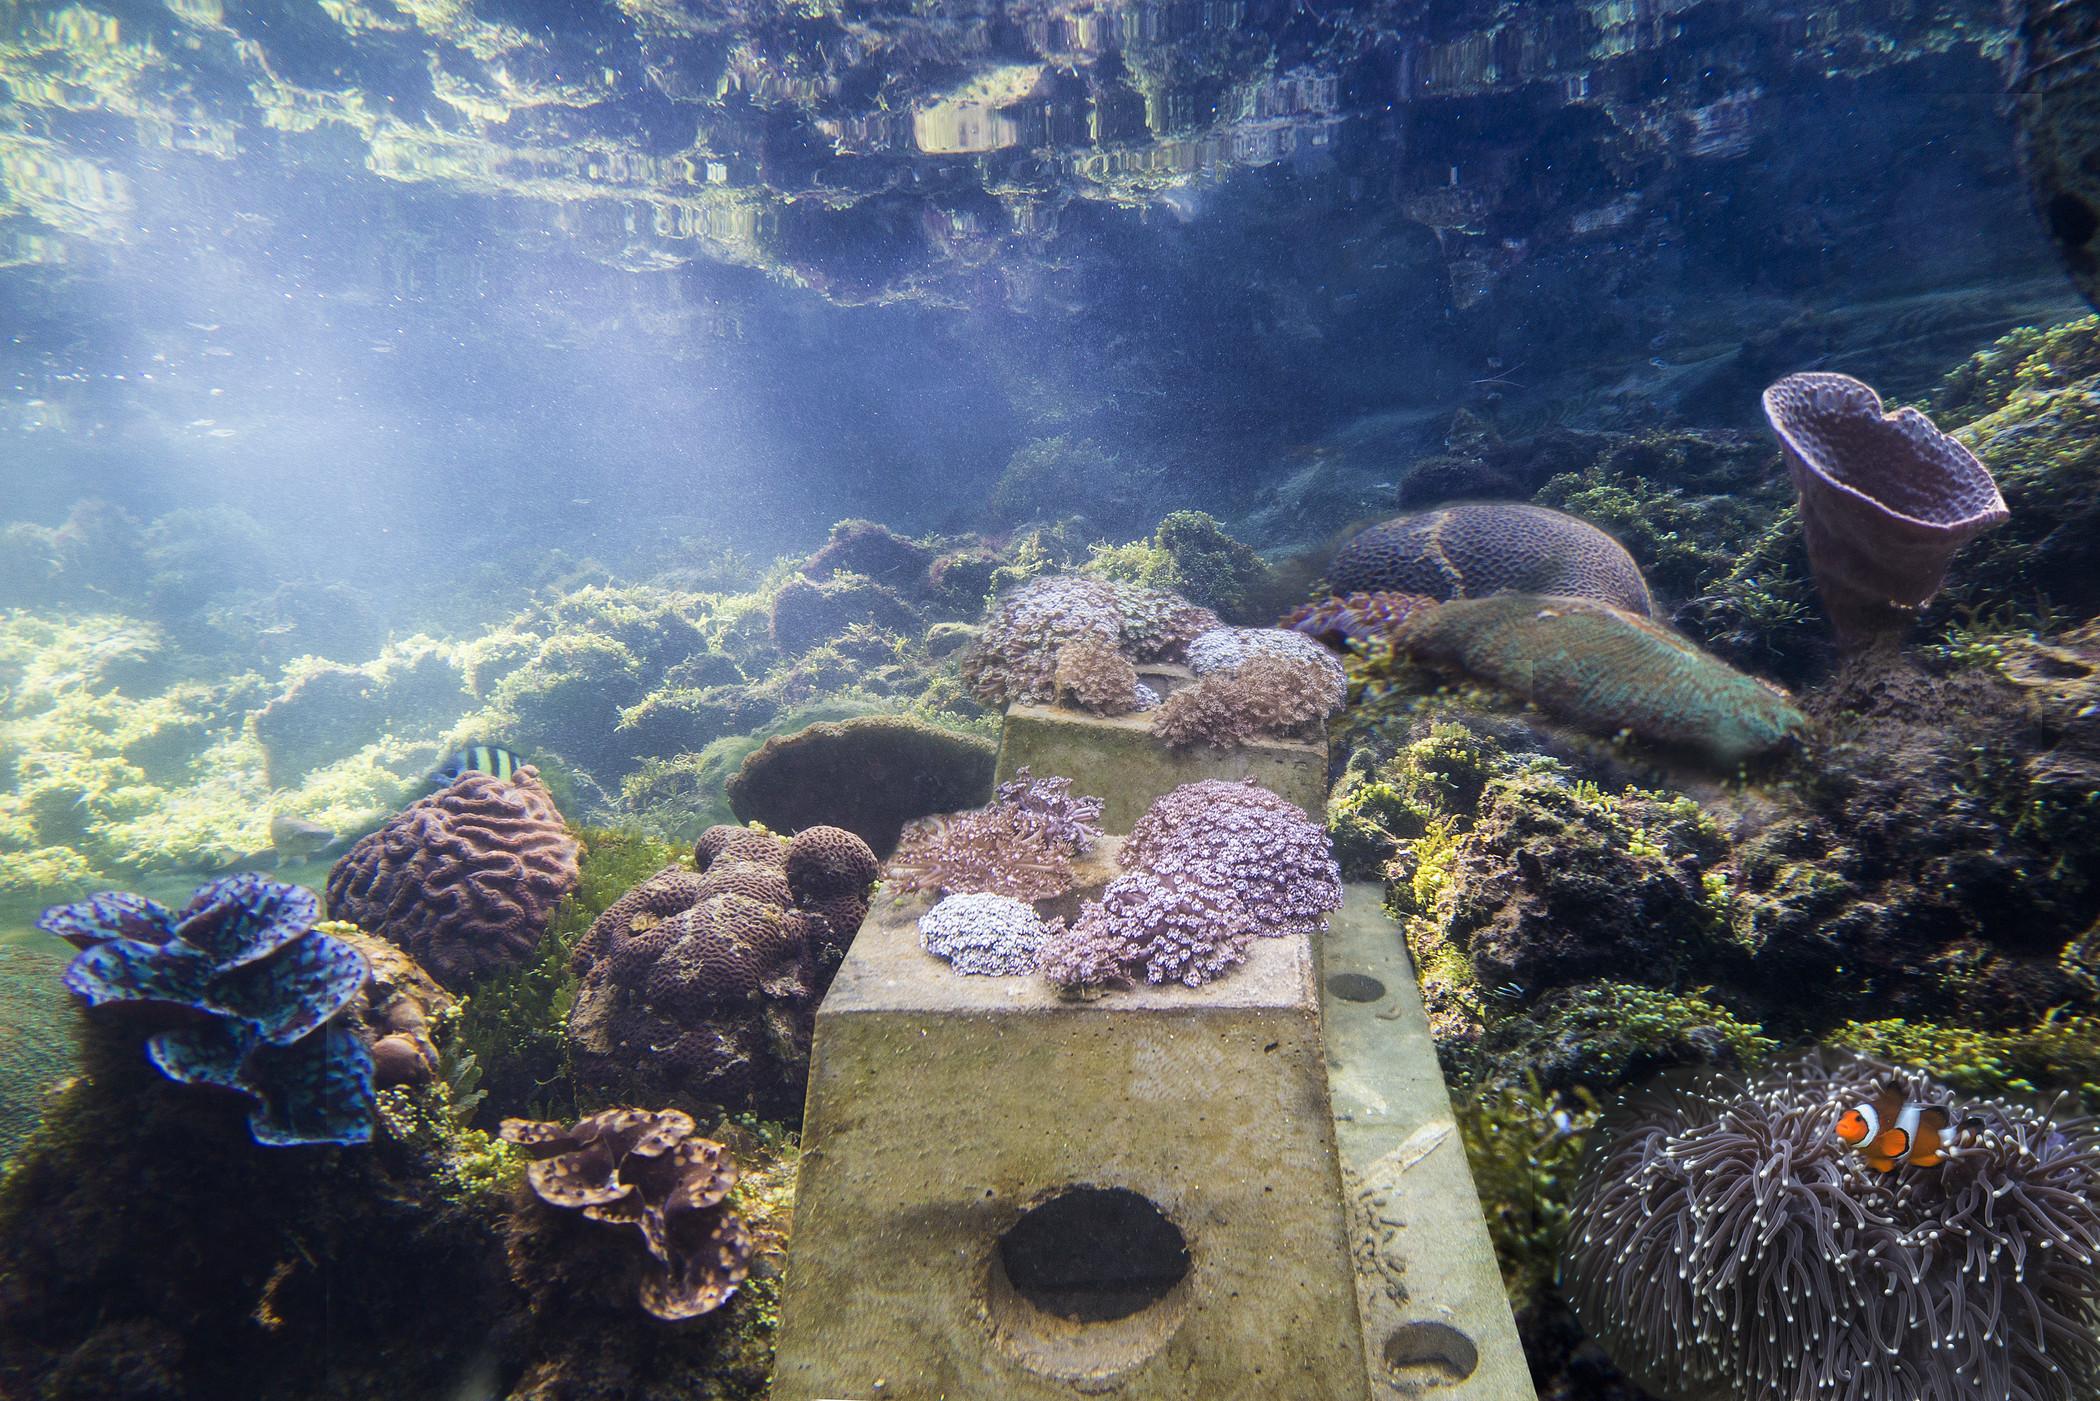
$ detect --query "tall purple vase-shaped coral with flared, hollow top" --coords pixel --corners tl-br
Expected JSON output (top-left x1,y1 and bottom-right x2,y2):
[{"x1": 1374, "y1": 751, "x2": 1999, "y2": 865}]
[{"x1": 1764, "y1": 374, "x2": 2008, "y2": 639}]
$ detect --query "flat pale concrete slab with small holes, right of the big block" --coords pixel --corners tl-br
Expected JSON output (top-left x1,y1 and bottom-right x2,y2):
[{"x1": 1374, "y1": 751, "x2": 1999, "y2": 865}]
[{"x1": 1321, "y1": 884, "x2": 1537, "y2": 1401}]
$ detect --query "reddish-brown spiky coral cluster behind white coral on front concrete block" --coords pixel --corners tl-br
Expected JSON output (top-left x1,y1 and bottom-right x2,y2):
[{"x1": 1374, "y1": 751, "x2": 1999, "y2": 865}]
[{"x1": 882, "y1": 769, "x2": 1103, "y2": 899}]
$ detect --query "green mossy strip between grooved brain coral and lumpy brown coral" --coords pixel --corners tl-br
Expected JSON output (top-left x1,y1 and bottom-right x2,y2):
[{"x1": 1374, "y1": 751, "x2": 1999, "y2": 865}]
[{"x1": 456, "y1": 828, "x2": 683, "y2": 1124}]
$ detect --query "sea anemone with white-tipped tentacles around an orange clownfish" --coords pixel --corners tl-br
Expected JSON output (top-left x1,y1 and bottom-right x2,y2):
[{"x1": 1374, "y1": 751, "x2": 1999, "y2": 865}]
[{"x1": 1562, "y1": 1052, "x2": 2100, "y2": 1401}]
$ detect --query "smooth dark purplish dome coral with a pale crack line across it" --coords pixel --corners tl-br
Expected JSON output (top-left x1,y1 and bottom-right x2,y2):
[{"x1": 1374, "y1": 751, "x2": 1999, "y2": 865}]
[{"x1": 1327, "y1": 502, "x2": 1655, "y2": 615}]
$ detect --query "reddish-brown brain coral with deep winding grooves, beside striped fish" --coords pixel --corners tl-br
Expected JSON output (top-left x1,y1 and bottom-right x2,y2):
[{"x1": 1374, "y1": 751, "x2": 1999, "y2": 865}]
[{"x1": 328, "y1": 765, "x2": 578, "y2": 987}]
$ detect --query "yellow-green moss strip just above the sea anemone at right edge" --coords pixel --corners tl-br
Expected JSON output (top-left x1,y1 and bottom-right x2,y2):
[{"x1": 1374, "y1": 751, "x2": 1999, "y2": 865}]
[{"x1": 1827, "y1": 1008, "x2": 2100, "y2": 1107}]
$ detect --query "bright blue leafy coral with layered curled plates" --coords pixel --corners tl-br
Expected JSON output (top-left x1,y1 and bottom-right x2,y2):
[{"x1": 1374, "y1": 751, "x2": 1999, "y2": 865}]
[{"x1": 36, "y1": 876, "x2": 372, "y2": 1147}]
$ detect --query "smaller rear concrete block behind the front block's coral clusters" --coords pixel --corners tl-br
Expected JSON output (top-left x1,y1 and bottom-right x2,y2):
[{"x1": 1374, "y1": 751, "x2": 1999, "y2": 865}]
[{"x1": 998, "y1": 706, "x2": 1327, "y2": 832}]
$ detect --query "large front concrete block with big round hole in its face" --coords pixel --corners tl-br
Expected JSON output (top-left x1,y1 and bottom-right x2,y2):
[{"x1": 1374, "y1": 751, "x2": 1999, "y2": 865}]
[{"x1": 773, "y1": 861, "x2": 1369, "y2": 1401}]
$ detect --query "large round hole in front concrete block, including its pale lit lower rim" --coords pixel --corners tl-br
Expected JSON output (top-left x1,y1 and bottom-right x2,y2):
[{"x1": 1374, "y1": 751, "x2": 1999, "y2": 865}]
[{"x1": 985, "y1": 1185, "x2": 1189, "y2": 1390}]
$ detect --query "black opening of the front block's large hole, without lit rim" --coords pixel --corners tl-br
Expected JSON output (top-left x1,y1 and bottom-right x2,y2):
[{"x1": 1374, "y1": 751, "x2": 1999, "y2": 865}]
[{"x1": 1000, "y1": 1187, "x2": 1189, "y2": 1323}]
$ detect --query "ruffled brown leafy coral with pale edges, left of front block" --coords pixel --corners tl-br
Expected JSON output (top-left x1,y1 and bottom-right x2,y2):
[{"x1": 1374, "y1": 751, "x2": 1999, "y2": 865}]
[{"x1": 502, "y1": 1109, "x2": 752, "y2": 1323}]
